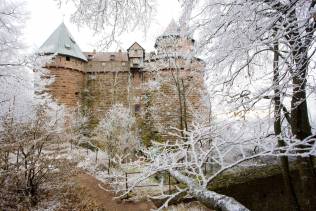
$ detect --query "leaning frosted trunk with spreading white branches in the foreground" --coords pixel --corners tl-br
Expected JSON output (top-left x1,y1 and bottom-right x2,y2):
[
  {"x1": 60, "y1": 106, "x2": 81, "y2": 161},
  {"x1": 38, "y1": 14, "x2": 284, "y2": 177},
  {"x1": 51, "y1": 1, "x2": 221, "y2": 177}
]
[{"x1": 107, "y1": 118, "x2": 316, "y2": 210}]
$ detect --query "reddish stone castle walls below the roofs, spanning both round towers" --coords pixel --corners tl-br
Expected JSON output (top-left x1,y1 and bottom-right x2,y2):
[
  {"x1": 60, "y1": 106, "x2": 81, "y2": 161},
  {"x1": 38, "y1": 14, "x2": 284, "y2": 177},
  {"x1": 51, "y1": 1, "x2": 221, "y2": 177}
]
[{"x1": 49, "y1": 61, "x2": 203, "y2": 143}]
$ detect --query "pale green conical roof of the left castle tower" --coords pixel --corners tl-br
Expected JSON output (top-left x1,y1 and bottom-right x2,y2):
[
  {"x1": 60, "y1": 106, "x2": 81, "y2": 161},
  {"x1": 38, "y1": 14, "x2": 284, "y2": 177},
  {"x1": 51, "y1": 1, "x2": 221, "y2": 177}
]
[{"x1": 38, "y1": 23, "x2": 87, "y2": 61}]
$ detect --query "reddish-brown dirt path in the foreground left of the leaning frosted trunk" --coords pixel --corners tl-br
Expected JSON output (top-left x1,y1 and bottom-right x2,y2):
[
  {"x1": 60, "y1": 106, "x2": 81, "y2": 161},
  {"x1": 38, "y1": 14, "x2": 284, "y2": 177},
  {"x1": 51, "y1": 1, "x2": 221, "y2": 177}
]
[{"x1": 75, "y1": 173, "x2": 154, "y2": 211}]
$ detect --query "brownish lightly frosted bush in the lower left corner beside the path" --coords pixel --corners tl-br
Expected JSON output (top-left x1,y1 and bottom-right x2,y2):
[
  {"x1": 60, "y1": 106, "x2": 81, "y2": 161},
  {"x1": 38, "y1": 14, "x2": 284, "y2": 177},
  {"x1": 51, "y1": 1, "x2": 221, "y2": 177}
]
[{"x1": 0, "y1": 105, "x2": 71, "y2": 210}]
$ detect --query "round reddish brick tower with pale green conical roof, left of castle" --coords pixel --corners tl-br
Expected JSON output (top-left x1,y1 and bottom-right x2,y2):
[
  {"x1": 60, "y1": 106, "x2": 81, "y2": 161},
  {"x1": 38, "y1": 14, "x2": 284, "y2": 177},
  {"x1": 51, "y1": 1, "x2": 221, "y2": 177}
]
[{"x1": 38, "y1": 23, "x2": 87, "y2": 107}]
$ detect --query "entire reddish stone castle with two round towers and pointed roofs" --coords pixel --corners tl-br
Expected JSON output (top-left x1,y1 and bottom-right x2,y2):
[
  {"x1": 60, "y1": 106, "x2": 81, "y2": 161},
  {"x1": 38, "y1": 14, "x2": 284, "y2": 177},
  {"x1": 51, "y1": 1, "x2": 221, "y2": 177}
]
[{"x1": 39, "y1": 20, "x2": 205, "y2": 142}]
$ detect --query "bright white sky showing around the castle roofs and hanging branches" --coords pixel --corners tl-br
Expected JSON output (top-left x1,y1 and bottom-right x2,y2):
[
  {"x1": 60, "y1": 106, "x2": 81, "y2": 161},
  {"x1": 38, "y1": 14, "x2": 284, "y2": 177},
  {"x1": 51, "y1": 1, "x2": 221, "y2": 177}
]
[{"x1": 25, "y1": 0, "x2": 180, "y2": 52}]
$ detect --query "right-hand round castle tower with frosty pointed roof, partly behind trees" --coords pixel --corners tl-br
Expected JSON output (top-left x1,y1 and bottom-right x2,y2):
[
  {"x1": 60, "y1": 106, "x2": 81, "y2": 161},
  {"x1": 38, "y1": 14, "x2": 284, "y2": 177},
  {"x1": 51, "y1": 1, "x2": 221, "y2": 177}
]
[{"x1": 145, "y1": 20, "x2": 204, "y2": 140}]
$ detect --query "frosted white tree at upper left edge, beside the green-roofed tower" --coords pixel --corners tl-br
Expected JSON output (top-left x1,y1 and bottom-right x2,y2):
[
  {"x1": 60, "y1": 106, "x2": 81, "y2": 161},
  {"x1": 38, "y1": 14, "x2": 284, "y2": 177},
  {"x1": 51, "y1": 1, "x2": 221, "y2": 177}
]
[{"x1": 0, "y1": 0, "x2": 30, "y2": 115}]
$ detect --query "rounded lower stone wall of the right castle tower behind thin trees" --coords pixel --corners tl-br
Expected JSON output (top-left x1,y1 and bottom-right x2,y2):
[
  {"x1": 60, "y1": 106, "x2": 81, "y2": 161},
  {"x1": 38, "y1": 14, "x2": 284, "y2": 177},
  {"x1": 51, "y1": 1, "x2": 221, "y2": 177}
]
[{"x1": 147, "y1": 70, "x2": 204, "y2": 137}]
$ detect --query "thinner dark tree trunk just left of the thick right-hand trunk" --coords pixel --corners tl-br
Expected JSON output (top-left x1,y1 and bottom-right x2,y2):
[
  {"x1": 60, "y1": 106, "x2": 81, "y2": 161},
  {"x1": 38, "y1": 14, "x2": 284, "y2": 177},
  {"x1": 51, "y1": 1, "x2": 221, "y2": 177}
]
[{"x1": 273, "y1": 37, "x2": 300, "y2": 211}]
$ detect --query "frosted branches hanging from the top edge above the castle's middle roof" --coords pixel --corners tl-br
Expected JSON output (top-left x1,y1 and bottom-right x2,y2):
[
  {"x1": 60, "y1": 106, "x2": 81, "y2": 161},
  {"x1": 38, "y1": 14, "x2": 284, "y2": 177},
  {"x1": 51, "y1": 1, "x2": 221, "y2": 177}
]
[{"x1": 56, "y1": 0, "x2": 156, "y2": 48}]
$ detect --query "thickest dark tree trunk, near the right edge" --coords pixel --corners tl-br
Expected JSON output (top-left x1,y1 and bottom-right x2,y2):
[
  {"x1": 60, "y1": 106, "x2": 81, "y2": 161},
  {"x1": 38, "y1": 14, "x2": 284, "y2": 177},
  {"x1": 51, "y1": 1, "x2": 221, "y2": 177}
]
[{"x1": 284, "y1": 6, "x2": 316, "y2": 210}]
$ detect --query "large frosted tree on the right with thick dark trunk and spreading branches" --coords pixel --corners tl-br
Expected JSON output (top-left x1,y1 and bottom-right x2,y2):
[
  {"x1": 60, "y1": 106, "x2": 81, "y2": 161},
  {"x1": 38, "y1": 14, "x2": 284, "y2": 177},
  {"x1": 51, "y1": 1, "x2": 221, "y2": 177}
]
[{"x1": 175, "y1": 0, "x2": 315, "y2": 208}]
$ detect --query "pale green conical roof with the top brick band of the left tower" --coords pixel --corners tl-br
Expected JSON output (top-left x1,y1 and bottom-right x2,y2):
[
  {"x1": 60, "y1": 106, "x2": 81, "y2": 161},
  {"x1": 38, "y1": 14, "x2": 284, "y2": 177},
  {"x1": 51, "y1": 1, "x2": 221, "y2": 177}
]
[{"x1": 38, "y1": 23, "x2": 87, "y2": 71}]
